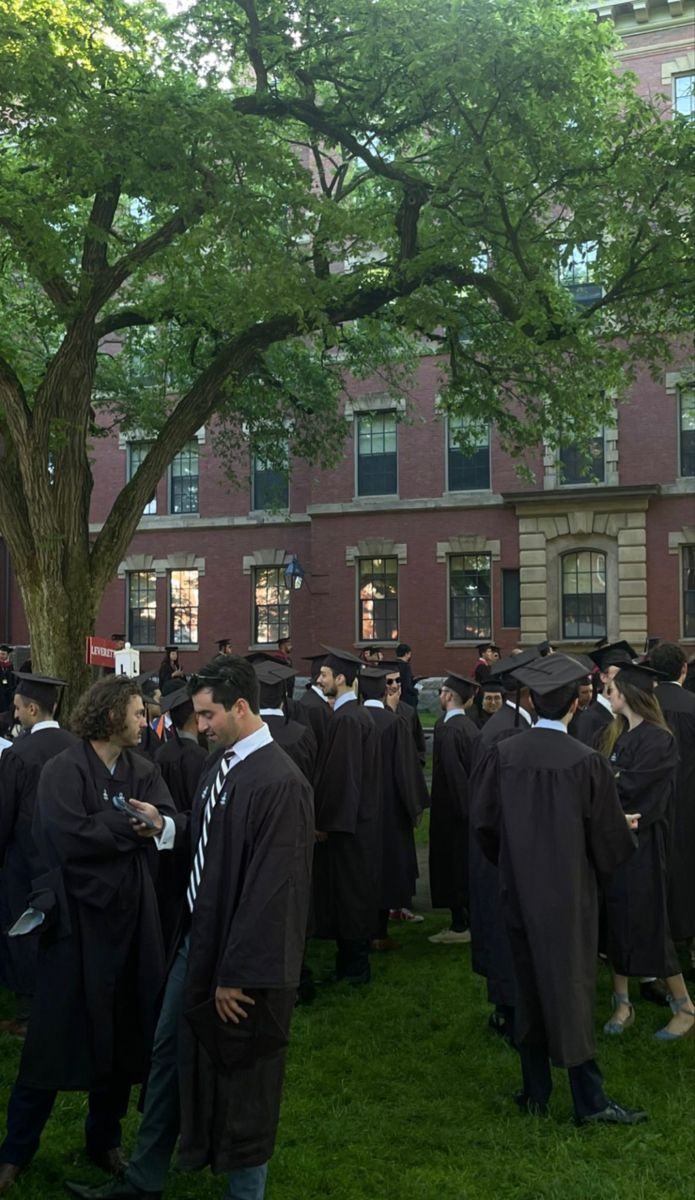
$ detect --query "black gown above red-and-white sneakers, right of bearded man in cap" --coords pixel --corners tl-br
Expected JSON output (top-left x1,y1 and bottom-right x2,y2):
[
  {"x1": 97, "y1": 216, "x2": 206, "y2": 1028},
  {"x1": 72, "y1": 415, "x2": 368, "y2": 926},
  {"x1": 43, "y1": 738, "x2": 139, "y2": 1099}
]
[{"x1": 365, "y1": 704, "x2": 430, "y2": 908}]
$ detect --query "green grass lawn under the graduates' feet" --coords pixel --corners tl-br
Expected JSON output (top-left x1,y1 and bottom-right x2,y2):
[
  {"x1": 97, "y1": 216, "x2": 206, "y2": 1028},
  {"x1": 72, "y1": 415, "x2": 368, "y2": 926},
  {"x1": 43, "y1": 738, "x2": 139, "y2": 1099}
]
[{"x1": 0, "y1": 913, "x2": 695, "y2": 1200}]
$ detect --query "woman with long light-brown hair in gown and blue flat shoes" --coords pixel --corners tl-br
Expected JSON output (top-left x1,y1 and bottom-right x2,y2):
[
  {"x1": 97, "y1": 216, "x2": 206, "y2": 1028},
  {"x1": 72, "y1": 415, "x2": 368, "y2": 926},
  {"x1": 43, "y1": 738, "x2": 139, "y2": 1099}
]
[{"x1": 599, "y1": 665, "x2": 695, "y2": 1042}]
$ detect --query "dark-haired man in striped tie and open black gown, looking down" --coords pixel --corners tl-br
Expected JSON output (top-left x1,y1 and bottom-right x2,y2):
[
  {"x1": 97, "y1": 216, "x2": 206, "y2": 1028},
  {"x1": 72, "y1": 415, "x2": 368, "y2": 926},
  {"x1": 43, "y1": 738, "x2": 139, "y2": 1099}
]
[{"x1": 67, "y1": 655, "x2": 314, "y2": 1200}]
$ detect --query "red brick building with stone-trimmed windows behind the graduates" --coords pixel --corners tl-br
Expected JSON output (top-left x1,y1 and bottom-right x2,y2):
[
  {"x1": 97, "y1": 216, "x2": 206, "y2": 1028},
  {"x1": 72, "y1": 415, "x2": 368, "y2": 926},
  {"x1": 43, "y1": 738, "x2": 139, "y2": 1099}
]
[{"x1": 0, "y1": 0, "x2": 695, "y2": 673}]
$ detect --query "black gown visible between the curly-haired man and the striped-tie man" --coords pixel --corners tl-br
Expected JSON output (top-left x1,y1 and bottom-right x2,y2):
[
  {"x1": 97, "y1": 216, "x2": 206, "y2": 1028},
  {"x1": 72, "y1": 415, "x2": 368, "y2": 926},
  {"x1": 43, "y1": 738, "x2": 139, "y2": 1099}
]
[{"x1": 155, "y1": 733, "x2": 210, "y2": 954}]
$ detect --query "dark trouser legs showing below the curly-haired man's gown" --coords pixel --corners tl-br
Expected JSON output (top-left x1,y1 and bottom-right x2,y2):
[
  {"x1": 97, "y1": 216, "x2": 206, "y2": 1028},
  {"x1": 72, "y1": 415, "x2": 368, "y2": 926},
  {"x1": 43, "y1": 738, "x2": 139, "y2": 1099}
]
[{"x1": 0, "y1": 1081, "x2": 131, "y2": 1166}]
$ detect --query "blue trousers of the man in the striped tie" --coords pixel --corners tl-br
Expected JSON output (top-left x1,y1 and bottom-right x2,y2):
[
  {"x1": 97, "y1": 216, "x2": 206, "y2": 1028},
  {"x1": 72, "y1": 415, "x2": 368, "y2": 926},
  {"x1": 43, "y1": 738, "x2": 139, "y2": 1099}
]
[{"x1": 125, "y1": 938, "x2": 268, "y2": 1200}]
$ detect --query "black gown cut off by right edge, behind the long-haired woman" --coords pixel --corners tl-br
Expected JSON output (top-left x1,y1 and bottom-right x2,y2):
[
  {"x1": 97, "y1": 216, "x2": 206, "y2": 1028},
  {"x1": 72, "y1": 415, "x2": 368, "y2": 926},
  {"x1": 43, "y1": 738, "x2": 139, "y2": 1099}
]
[{"x1": 654, "y1": 683, "x2": 695, "y2": 942}]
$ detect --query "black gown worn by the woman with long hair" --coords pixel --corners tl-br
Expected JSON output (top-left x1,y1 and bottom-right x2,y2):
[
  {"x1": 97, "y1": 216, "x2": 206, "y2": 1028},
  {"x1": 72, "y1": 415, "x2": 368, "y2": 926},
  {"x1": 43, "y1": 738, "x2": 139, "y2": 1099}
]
[{"x1": 605, "y1": 721, "x2": 681, "y2": 978}]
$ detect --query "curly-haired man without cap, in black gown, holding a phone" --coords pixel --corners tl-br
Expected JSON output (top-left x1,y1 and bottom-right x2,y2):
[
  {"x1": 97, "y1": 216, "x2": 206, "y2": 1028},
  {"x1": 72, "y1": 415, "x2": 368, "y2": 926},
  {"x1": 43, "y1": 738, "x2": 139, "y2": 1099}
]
[{"x1": 0, "y1": 676, "x2": 175, "y2": 1193}]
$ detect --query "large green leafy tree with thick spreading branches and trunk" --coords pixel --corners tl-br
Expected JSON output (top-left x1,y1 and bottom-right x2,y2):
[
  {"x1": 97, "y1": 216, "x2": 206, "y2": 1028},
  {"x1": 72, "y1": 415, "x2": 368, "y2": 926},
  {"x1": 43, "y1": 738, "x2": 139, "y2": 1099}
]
[{"x1": 0, "y1": 0, "x2": 694, "y2": 691}]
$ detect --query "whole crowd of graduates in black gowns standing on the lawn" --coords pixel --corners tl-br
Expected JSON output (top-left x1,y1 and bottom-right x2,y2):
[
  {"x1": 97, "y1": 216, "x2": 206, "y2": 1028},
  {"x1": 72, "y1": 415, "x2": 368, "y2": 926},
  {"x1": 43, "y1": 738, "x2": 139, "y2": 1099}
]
[{"x1": 0, "y1": 640, "x2": 695, "y2": 1200}]
